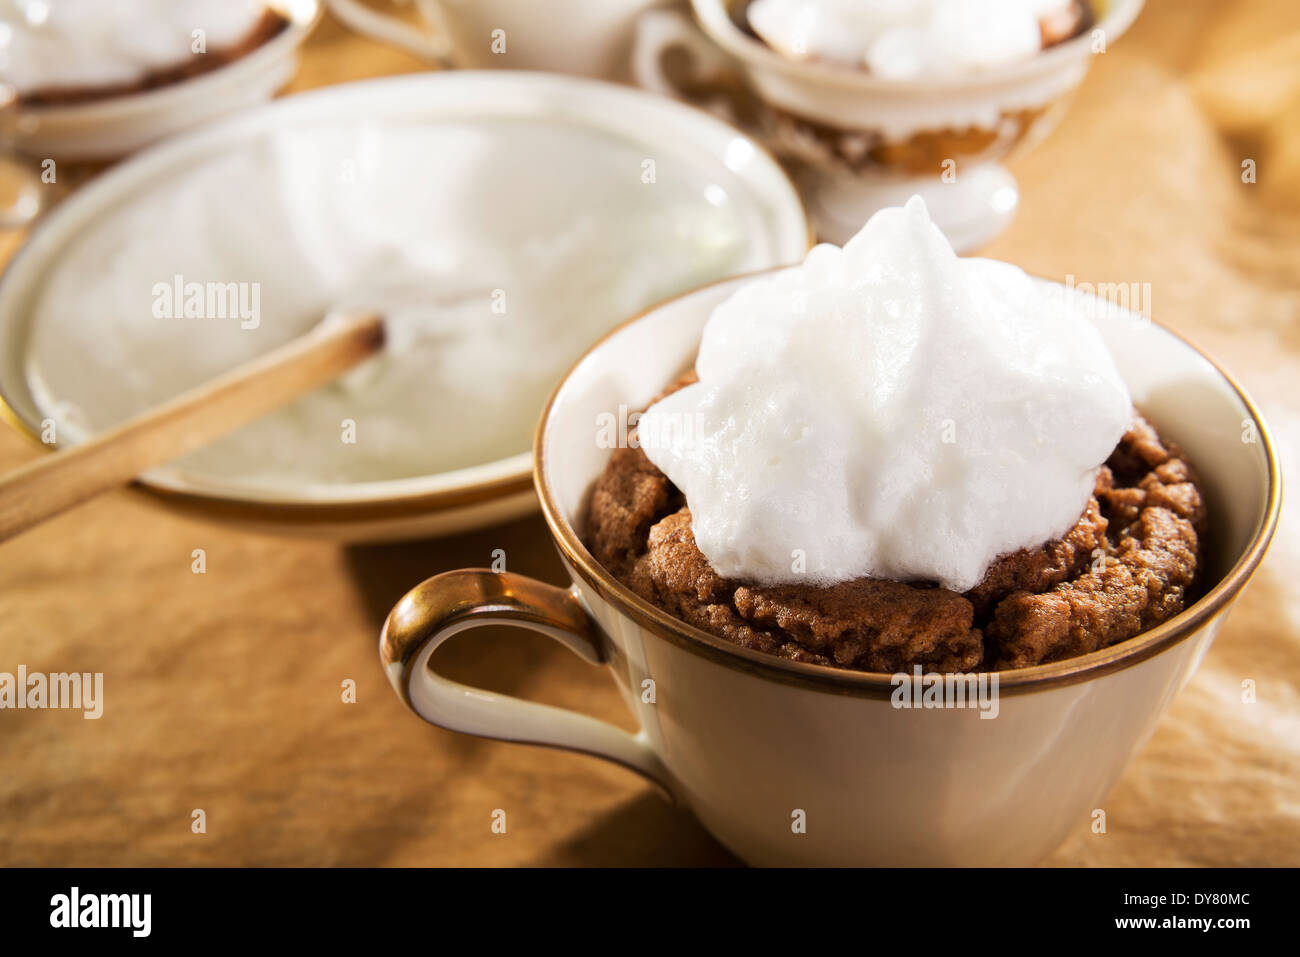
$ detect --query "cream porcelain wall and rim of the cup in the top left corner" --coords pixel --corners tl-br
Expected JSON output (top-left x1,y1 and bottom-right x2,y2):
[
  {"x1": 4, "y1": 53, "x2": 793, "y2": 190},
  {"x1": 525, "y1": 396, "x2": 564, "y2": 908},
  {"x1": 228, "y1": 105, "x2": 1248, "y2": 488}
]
[{"x1": 12, "y1": 0, "x2": 321, "y2": 160}]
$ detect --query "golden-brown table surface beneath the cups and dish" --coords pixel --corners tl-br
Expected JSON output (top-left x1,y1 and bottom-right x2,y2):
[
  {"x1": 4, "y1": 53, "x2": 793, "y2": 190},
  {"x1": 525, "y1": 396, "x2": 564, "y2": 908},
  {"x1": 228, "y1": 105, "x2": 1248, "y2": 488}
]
[{"x1": 0, "y1": 0, "x2": 1300, "y2": 865}]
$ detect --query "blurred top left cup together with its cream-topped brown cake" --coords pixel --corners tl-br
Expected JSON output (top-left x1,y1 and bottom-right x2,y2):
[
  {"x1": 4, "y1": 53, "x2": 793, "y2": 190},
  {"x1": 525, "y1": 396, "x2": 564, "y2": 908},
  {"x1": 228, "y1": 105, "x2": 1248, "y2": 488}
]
[{"x1": 0, "y1": 0, "x2": 321, "y2": 161}]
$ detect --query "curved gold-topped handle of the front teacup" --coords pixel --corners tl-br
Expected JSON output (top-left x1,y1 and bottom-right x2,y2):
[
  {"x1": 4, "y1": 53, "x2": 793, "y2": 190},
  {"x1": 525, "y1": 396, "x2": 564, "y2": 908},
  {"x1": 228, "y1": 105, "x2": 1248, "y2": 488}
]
[{"x1": 380, "y1": 568, "x2": 672, "y2": 797}]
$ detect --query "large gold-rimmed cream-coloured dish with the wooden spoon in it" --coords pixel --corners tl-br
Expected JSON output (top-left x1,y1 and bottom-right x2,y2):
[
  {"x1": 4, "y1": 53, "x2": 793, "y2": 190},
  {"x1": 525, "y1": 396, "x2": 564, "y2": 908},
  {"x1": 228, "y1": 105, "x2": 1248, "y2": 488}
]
[{"x1": 0, "y1": 72, "x2": 809, "y2": 541}]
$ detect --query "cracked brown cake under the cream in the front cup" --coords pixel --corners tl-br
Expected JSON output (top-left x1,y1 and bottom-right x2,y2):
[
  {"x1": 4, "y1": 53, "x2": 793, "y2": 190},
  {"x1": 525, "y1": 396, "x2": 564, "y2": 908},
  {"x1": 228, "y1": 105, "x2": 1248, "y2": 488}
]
[{"x1": 584, "y1": 374, "x2": 1205, "y2": 672}]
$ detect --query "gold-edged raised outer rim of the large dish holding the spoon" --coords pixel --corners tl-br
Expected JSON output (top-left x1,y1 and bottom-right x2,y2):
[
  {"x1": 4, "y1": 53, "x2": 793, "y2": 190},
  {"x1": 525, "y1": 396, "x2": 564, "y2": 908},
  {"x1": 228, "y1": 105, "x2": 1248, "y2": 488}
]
[{"x1": 0, "y1": 72, "x2": 810, "y2": 541}]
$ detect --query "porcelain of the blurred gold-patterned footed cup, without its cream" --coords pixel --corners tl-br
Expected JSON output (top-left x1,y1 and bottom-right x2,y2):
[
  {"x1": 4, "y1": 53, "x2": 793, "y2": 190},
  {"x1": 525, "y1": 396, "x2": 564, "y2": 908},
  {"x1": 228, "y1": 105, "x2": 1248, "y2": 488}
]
[{"x1": 633, "y1": 0, "x2": 1143, "y2": 251}]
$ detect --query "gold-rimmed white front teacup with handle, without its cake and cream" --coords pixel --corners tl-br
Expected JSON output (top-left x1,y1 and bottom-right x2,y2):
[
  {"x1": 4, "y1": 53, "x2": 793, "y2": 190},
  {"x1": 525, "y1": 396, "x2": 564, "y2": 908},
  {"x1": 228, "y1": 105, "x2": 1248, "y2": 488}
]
[{"x1": 380, "y1": 270, "x2": 1281, "y2": 865}]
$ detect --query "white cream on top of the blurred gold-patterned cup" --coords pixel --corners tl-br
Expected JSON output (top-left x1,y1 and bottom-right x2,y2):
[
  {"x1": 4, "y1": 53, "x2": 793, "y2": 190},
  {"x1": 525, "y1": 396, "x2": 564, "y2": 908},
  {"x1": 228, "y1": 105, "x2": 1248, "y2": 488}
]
[{"x1": 749, "y1": 0, "x2": 1071, "y2": 79}]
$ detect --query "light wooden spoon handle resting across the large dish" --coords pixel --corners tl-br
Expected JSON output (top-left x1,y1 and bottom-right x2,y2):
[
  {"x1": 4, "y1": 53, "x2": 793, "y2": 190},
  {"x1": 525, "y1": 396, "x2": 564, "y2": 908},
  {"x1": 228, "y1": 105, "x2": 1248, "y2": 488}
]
[{"x1": 0, "y1": 313, "x2": 384, "y2": 541}]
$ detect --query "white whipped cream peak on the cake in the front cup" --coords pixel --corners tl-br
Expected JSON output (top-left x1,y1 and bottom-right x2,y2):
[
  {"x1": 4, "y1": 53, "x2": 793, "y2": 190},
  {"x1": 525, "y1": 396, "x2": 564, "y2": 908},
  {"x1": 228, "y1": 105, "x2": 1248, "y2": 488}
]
[{"x1": 640, "y1": 196, "x2": 1132, "y2": 592}]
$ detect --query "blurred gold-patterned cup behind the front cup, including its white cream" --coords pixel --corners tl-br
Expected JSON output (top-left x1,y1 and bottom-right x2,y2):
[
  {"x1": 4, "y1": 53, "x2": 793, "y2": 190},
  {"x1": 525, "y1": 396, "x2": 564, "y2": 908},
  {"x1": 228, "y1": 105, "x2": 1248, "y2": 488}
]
[{"x1": 633, "y1": 0, "x2": 1141, "y2": 251}]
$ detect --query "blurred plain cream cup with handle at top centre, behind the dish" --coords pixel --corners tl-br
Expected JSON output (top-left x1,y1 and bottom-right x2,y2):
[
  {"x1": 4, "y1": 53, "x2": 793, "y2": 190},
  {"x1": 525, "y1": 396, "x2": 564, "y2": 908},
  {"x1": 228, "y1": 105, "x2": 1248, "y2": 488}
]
[{"x1": 329, "y1": 0, "x2": 664, "y2": 79}]
